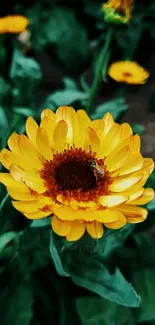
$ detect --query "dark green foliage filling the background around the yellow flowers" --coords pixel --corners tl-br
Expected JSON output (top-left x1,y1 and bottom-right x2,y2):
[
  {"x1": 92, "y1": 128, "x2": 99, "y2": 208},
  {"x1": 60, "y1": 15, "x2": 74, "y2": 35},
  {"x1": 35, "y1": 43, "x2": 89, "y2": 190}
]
[{"x1": 0, "y1": 0, "x2": 155, "y2": 325}]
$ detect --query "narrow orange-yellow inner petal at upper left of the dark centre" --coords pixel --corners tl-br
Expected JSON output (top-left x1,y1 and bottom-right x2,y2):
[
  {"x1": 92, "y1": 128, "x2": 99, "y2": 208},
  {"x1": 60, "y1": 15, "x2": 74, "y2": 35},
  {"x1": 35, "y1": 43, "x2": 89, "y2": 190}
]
[{"x1": 36, "y1": 128, "x2": 53, "y2": 160}]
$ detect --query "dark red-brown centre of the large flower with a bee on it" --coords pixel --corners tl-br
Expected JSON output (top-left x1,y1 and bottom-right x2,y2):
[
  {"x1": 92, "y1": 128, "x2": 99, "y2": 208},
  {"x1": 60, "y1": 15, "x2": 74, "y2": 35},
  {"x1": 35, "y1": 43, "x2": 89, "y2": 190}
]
[{"x1": 40, "y1": 147, "x2": 111, "y2": 202}]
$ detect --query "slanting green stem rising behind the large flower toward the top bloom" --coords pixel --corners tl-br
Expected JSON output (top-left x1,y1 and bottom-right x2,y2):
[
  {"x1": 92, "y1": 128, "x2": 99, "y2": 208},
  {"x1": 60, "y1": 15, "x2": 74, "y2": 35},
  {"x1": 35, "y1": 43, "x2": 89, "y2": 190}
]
[{"x1": 87, "y1": 29, "x2": 112, "y2": 114}]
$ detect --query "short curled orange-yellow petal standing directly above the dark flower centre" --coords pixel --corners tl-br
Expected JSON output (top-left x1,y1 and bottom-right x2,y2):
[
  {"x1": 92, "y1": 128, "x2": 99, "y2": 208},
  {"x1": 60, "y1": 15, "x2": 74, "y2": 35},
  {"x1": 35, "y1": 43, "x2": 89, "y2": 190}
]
[{"x1": 83, "y1": 127, "x2": 100, "y2": 152}]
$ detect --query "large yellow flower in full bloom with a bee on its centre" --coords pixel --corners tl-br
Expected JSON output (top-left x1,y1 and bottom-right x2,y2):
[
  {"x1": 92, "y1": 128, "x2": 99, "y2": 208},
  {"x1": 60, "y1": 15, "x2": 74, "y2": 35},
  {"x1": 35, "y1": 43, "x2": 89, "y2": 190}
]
[{"x1": 0, "y1": 106, "x2": 154, "y2": 241}]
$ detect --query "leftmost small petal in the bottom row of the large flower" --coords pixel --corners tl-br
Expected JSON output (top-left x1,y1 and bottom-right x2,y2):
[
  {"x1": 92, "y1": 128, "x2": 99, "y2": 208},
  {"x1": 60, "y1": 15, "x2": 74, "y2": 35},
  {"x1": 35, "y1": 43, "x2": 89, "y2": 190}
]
[{"x1": 51, "y1": 216, "x2": 71, "y2": 236}]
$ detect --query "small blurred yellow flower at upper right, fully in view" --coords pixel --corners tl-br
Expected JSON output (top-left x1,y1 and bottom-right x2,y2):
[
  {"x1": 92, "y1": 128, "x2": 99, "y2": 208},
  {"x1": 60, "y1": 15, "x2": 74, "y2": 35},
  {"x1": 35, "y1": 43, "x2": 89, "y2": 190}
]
[{"x1": 108, "y1": 61, "x2": 149, "y2": 84}]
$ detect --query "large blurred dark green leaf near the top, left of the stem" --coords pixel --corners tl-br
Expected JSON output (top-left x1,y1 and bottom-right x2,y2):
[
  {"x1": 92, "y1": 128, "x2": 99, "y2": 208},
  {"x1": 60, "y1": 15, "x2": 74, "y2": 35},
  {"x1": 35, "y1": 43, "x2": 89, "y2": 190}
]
[{"x1": 33, "y1": 6, "x2": 89, "y2": 70}]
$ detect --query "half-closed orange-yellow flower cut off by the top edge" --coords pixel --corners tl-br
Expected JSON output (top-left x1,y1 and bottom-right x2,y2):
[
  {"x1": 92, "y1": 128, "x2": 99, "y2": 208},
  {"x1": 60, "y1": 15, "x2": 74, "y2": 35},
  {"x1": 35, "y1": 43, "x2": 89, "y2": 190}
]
[{"x1": 103, "y1": 0, "x2": 134, "y2": 22}]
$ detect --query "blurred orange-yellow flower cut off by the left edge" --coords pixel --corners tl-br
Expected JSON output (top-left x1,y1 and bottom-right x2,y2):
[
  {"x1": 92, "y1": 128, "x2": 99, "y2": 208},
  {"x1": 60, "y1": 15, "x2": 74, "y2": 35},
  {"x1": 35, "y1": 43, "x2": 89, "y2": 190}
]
[{"x1": 0, "y1": 15, "x2": 29, "y2": 34}]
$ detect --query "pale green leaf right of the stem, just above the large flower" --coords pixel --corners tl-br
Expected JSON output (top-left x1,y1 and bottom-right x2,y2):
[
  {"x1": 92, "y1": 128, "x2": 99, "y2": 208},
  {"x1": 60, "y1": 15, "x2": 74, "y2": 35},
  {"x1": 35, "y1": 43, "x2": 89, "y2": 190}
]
[{"x1": 91, "y1": 97, "x2": 127, "y2": 120}]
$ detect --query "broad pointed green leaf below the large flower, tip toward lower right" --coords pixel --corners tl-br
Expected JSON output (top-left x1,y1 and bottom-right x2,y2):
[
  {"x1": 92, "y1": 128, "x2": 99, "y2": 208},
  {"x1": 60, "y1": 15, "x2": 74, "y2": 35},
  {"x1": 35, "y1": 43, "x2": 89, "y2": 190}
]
[{"x1": 68, "y1": 260, "x2": 140, "y2": 307}]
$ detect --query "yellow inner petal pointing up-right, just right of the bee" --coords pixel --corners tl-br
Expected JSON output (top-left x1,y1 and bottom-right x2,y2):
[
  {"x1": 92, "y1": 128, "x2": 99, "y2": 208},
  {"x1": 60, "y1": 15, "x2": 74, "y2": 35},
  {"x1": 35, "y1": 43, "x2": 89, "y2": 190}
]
[{"x1": 105, "y1": 146, "x2": 130, "y2": 172}]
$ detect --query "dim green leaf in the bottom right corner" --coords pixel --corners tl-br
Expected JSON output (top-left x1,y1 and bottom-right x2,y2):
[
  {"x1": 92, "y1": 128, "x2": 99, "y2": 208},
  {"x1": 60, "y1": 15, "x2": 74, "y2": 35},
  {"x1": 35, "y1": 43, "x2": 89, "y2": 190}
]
[{"x1": 132, "y1": 269, "x2": 155, "y2": 323}]
